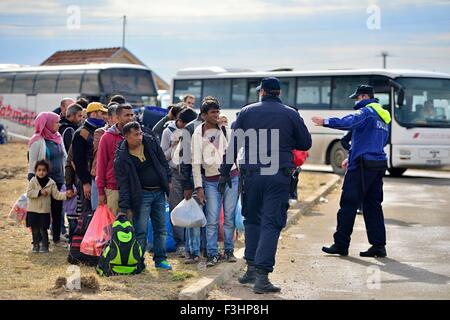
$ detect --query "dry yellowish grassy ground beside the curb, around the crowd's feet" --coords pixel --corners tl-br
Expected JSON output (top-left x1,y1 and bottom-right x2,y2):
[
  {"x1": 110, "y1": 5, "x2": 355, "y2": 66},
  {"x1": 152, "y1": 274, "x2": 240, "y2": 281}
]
[{"x1": 0, "y1": 143, "x2": 328, "y2": 300}]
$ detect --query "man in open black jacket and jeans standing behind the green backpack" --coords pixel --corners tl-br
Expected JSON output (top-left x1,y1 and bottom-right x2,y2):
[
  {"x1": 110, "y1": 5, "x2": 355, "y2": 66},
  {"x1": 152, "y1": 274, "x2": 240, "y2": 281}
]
[{"x1": 114, "y1": 121, "x2": 172, "y2": 270}]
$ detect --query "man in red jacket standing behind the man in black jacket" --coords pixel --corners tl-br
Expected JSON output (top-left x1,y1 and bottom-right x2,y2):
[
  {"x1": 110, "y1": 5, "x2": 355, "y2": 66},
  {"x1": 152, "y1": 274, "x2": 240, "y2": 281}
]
[{"x1": 95, "y1": 103, "x2": 133, "y2": 215}]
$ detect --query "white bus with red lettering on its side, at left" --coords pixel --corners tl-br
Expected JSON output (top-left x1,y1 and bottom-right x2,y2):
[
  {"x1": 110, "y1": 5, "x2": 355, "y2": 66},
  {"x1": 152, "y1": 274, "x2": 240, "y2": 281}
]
[{"x1": 0, "y1": 64, "x2": 158, "y2": 137}]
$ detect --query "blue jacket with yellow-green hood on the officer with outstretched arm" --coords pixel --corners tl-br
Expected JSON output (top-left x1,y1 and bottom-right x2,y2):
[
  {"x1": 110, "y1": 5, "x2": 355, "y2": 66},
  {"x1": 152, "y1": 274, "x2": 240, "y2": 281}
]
[{"x1": 324, "y1": 99, "x2": 391, "y2": 170}]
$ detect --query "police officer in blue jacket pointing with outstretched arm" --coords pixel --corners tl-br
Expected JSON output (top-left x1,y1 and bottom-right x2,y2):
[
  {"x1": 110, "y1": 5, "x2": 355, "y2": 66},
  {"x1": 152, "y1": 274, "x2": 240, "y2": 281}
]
[{"x1": 312, "y1": 85, "x2": 391, "y2": 257}]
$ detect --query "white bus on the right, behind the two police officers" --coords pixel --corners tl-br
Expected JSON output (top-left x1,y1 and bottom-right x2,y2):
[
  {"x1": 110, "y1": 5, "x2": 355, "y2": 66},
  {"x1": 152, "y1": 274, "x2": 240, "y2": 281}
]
[{"x1": 171, "y1": 67, "x2": 450, "y2": 176}]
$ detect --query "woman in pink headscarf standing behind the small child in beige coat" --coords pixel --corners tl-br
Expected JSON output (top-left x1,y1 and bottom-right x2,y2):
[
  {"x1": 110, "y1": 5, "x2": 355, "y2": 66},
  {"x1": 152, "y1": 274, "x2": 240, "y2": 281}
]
[{"x1": 28, "y1": 112, "x2": 67, "y2": 245}]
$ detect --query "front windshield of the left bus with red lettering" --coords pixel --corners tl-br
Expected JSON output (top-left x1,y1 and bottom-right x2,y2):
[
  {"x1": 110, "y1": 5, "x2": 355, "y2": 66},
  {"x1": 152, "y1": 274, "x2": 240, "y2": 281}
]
[{"x1": 100, "y1": 69, "x2": 157, "y2": 102}]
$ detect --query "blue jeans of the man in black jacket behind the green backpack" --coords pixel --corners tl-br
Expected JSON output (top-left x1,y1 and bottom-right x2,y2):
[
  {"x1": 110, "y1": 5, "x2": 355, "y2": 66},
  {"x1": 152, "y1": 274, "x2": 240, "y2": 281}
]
[{"x1": 133, "y1": 190, "x2": 167, "y2": 262}]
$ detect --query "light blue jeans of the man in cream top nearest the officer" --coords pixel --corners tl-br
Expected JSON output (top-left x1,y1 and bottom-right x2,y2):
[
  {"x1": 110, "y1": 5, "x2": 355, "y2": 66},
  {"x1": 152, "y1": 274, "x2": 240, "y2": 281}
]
[{"x1": 203, "y1": 177, "x2": 239, "y2": 257}]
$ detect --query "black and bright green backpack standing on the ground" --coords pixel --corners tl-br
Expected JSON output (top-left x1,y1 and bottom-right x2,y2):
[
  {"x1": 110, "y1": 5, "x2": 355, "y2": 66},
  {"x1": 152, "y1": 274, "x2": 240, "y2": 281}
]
[{"x1": 96, "y1": 215, "x2": 145, "y2": 277}]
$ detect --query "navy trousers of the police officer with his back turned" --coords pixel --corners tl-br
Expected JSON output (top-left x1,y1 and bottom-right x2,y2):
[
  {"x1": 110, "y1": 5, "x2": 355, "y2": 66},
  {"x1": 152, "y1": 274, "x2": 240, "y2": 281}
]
[{"x1": 242, "y1": 170, "x2": 291, "y2": 272}]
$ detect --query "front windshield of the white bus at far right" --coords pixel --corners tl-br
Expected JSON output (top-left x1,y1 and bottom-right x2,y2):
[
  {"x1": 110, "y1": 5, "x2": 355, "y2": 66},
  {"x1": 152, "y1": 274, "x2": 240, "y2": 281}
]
[{"x1": 395, "y1": 78, "x2": 450, "y2": 128}]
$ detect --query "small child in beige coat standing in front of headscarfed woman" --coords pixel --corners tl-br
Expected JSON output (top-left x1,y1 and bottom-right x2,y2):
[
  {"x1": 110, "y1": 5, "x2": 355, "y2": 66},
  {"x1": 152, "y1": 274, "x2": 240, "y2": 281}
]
[{"x1": 27, "y1": 160, "x2": 73, "y2": 253}]
